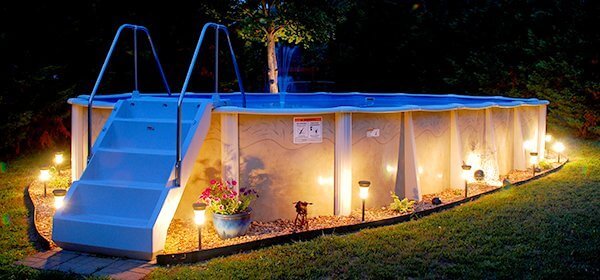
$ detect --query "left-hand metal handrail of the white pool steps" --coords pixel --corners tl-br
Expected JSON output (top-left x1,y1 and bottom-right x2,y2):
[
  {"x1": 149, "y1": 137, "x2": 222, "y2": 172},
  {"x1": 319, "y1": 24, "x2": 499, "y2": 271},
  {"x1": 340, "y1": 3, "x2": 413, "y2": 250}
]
[{"x1": 87, "y1": 24, "x2": 171, "y2": 163}]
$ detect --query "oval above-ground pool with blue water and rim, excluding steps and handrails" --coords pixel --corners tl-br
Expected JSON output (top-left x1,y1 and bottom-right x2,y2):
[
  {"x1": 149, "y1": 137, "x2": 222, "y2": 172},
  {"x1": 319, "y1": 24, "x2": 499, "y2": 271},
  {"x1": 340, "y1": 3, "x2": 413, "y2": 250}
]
[{"x1": 69, "y1": 93, "x2": 548, "y2": 220}]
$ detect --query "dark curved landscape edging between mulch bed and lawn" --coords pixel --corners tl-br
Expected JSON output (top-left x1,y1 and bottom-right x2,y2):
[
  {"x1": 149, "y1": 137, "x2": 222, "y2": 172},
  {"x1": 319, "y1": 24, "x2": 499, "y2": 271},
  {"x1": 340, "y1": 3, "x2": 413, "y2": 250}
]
[{"x1": 156, "y1": 158, "x2": 569, "y2": 266}]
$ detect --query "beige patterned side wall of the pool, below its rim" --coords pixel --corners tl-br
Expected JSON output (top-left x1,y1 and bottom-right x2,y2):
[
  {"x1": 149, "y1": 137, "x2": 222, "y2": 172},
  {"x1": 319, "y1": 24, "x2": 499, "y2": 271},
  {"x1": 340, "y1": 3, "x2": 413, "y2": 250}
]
[{"x1": 71, "y1": 99, "x2": 546, "y2": 221}]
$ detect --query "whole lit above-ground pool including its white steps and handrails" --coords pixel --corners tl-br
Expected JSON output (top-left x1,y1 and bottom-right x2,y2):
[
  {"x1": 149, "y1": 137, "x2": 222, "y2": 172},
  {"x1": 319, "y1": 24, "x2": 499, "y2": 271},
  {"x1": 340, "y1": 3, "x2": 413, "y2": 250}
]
[{"x1": 52, "y1": 23, "x2": 548, "y2": 259}]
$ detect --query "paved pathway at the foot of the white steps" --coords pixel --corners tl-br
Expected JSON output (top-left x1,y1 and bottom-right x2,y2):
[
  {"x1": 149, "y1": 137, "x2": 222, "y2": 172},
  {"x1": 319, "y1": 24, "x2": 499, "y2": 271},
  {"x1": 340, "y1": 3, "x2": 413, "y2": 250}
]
[{"x1": 17, "y1": 248, "x2": 155, "y2": 280}]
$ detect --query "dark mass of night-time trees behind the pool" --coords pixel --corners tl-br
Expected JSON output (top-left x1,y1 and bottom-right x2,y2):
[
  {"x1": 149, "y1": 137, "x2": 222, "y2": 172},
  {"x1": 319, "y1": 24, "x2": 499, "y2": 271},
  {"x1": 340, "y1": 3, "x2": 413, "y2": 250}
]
[{"x1": 0, "y1": 0, "x2": 600, "y2": 155}]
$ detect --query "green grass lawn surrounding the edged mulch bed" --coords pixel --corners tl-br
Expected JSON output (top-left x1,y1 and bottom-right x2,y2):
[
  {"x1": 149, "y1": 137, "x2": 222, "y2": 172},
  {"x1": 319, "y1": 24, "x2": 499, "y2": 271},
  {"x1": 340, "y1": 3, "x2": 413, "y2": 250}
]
[{"x1": 0, "y1": 138, "x2": 600, "y2": 279}]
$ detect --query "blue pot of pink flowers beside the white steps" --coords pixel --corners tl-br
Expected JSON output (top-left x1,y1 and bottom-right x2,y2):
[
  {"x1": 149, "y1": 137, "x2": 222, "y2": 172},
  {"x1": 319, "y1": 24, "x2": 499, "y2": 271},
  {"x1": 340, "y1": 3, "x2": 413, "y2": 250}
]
[{"x1": 199, "y1": 179, "x2": 258, "y2": 239}]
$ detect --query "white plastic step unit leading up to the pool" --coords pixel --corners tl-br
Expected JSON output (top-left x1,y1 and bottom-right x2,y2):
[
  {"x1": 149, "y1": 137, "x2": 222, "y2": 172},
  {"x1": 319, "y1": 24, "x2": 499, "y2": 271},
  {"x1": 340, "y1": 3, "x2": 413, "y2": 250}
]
[{"x1": 52, "y1": 97, "x2": 212, "y2": 259}]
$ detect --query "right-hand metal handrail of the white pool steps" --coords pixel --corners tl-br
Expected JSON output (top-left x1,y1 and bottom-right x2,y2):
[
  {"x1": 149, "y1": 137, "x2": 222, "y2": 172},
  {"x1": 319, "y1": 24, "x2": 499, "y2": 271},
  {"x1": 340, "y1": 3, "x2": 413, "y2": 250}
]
[{"x1": 175, "y1": 22, "x2": 246, "y2": 186}]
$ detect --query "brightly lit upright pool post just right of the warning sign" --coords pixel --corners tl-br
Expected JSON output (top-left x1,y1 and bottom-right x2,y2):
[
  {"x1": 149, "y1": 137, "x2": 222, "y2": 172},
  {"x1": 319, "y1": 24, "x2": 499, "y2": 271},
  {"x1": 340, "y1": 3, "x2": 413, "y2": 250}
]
[{"x1": 333, "y1": 113, "x2": 352, "y2": 216}]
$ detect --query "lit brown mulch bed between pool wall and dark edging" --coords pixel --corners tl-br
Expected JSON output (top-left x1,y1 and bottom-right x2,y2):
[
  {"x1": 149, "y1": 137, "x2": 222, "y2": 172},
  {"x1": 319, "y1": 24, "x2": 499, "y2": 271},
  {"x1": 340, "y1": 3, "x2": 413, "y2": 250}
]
[{"x1": 29, "y1": 158, "x2": 560, "y2": 254}]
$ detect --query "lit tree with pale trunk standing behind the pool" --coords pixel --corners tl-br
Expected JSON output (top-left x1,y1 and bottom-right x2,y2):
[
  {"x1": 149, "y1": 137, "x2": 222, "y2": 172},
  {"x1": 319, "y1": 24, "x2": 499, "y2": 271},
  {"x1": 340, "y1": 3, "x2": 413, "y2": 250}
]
[{"x1": 213, "y1": 0, "x2": 350, "y2": 93}]
